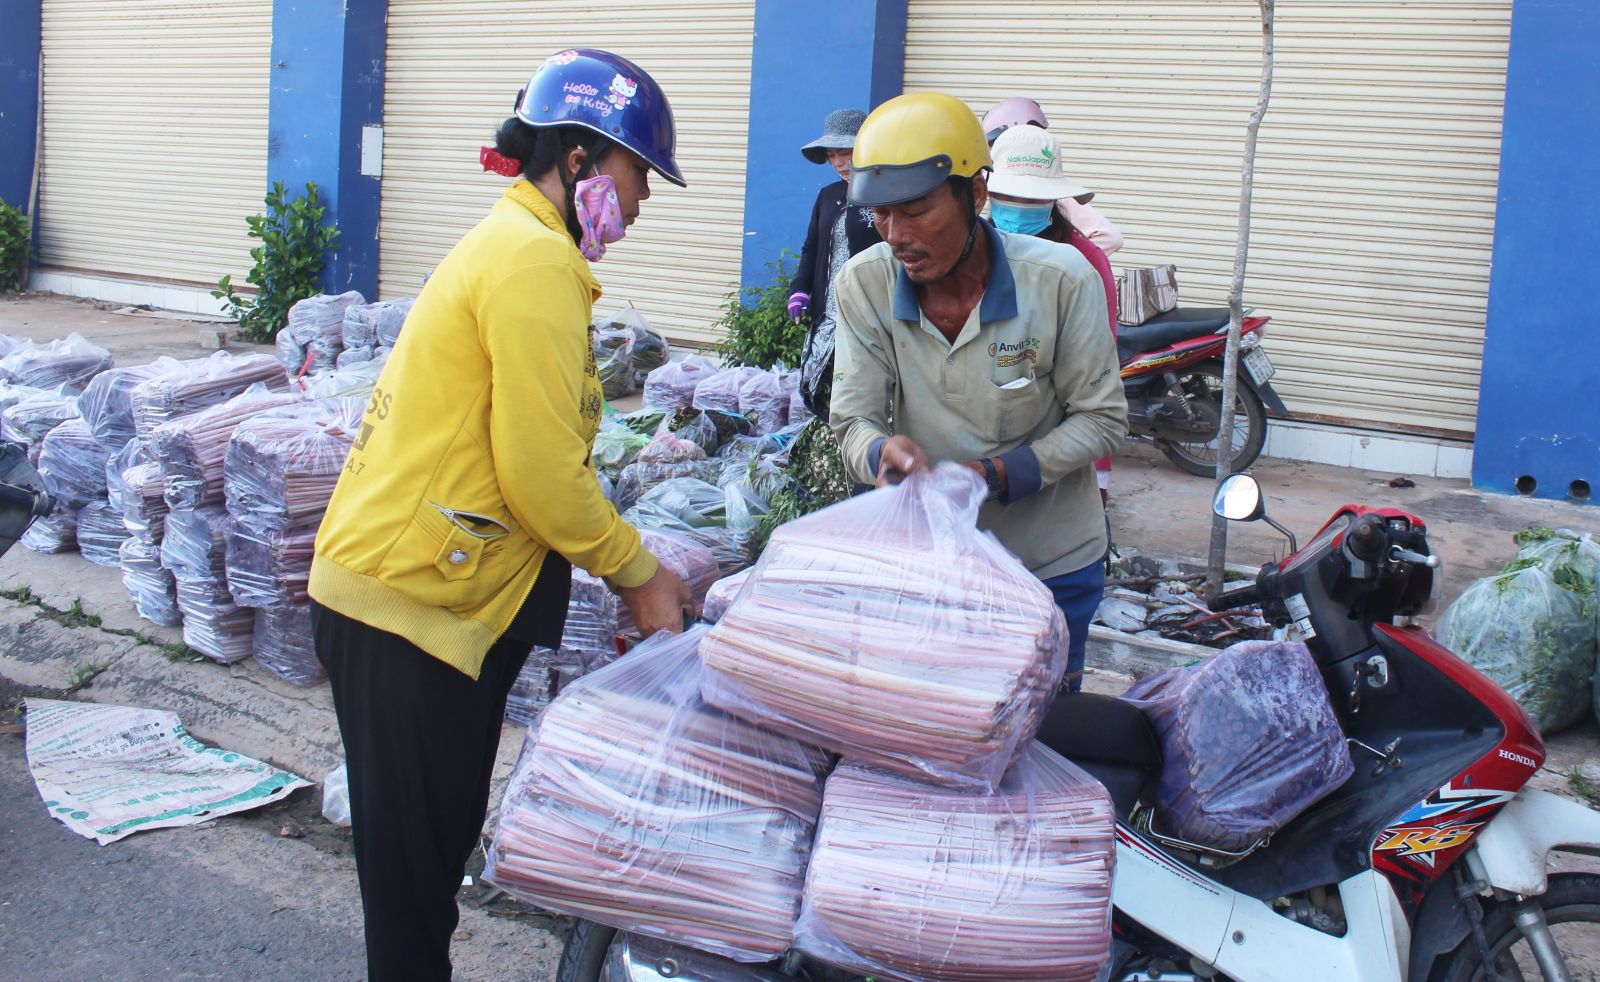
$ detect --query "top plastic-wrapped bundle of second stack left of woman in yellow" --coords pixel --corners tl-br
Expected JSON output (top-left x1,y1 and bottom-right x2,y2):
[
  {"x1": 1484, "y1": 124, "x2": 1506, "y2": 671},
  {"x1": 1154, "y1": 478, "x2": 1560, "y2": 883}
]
[{"x1": 150, "y1": 384, "x2": 301, "y2": 509}]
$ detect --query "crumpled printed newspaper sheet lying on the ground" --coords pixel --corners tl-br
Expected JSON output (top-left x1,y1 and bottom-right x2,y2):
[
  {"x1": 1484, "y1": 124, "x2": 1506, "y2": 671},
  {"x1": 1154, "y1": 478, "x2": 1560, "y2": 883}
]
[{"x1": 27, "y1": 699, "x2": 310, "y2": 846}]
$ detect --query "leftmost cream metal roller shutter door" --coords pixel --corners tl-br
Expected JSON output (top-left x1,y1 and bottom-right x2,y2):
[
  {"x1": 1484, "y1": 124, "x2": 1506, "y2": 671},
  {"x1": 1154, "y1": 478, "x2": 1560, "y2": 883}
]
[{"x1": 38, "y1": 0, "x2": 272, "y2": 285}]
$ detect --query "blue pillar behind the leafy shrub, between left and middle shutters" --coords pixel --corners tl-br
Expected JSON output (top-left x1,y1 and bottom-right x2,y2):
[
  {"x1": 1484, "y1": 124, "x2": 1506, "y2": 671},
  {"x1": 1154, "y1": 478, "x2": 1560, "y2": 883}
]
[{"x1": 267, "y1": 0, "x2": 389, "y2": 299}]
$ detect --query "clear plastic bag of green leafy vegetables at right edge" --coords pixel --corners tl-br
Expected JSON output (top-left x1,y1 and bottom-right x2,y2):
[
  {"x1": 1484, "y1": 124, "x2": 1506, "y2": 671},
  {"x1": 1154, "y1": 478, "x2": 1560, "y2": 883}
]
[{"x1": 1437, "y1": 558, "x2": 1595, "y2": 733}]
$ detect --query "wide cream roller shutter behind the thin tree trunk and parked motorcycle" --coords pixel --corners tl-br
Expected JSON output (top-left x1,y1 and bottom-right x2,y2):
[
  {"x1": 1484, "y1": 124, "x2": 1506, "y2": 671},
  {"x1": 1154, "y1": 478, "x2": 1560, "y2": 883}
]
[{"x1": 906, "y1": 0, "x2": 1510, "y2": 435}]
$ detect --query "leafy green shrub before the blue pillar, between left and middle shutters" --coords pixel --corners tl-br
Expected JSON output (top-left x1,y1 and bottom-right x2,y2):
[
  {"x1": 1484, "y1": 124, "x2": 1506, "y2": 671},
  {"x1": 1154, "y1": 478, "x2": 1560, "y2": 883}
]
[{"x1": 211, "y1": 181, "x2": 339, "y2": 341}]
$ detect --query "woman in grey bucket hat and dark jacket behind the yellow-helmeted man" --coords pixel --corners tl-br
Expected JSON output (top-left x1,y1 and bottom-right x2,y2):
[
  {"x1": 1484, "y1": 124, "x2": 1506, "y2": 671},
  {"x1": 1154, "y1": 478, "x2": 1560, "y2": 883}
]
[{"x1": 789, "y1": 109, "x2": 882, "y2": 421}]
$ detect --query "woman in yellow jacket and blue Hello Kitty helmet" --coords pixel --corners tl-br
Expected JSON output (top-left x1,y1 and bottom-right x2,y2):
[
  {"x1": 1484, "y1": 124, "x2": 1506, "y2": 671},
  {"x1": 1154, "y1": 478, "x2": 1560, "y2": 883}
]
[{"x1": 310, "y1": 50, "x2": 691, "y2": 979}]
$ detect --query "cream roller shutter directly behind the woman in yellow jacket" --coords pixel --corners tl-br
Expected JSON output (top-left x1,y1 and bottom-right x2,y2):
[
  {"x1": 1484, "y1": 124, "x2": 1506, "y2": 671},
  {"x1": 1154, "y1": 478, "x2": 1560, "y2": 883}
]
[{"x1": 379, "y1": 0, "x2": 755, "y2": 342}]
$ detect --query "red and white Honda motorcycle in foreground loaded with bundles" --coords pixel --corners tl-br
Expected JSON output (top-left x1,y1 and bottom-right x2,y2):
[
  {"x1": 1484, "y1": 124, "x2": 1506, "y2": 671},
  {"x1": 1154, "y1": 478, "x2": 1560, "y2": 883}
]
[{"x1": 558, "y1": 475, "x2": 1600, "y2": 982}]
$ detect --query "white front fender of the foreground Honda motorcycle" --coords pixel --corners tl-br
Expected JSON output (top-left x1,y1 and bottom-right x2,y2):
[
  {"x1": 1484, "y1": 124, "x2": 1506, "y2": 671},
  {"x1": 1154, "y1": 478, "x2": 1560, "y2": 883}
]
[{"x1": 1469, "y1": 788, "x2": 1600, "y2": 897}]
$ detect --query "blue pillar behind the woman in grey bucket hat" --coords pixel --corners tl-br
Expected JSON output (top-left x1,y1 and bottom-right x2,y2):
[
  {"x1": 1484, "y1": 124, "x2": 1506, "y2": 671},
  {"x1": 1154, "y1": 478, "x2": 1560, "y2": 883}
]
[{"x1": 741, "y1": 0, "x2": 907, "y2": 286}]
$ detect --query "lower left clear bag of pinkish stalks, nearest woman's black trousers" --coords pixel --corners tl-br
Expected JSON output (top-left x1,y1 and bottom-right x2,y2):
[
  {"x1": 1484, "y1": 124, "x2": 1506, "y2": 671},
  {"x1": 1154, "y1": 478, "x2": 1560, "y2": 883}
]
[{"x1": 483, "y1": 629, "x2": 827, "y2": 963}]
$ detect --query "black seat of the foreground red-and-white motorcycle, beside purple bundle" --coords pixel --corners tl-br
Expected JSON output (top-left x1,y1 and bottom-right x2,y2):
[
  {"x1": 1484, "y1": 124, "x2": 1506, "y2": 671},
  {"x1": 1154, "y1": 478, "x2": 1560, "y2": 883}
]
[{"x1": 1037, "y1": 693, "x2": 1162, "y2": 816}]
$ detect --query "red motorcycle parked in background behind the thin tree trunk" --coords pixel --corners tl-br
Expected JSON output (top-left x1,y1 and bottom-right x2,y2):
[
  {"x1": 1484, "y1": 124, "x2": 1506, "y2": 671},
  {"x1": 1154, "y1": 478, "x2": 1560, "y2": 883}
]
[{"x1": 1117, "y1": 307, "x2": 1288, "y2": 477}]
